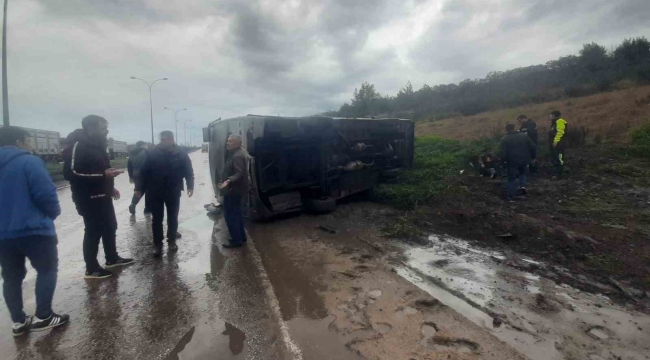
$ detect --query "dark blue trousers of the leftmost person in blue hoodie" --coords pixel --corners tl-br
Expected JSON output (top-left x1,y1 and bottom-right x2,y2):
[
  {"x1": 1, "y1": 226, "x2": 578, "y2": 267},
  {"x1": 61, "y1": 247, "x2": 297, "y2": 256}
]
[{"x1": 0, "y1": 235, "x2": 59, "y2": 323}]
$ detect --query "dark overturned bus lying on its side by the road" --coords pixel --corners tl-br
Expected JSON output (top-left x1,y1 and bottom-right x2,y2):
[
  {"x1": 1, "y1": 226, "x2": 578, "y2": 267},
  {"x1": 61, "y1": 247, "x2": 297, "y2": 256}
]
[{"x1": 203, "y1": 115, "x2": 415, "y2": 220}]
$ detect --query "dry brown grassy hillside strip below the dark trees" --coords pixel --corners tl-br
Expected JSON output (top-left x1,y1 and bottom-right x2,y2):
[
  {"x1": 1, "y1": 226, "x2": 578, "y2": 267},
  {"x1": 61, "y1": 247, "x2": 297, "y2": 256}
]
[{"x1": 416, "y1": 86, "x2": 650, "y2": 142}]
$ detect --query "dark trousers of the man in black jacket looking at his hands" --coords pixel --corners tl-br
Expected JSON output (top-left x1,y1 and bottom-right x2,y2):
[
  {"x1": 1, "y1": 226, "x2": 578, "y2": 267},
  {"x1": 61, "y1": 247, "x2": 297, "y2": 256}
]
[{"x1": 77, "y1": 198, "x2": 118, "y2": 272}]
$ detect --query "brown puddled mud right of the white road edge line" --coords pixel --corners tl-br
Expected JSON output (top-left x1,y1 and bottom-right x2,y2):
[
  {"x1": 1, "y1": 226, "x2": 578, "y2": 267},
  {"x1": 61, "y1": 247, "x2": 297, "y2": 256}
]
[{"x1": 250, "y1": 203, "x2": 650, "y2": 360}]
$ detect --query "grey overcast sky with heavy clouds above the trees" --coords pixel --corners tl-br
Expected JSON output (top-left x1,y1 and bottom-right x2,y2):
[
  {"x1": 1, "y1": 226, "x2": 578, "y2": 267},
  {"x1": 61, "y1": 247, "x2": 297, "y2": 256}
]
[{"x1": 1, "y1": 0, "x2": 650, "y2": 142}]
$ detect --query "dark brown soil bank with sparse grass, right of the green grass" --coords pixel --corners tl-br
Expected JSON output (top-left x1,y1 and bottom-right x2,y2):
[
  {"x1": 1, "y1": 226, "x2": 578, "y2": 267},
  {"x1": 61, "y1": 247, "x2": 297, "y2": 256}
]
[{"x1": 389, "y1": 147, "x2": 650, "y2": 308}]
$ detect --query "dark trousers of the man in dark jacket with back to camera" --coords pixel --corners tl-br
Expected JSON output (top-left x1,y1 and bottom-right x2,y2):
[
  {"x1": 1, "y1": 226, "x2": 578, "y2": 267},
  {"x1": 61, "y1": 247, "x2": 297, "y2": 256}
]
[{"x1": 148, "y1": 191, "x2": 181, "y2": 246}]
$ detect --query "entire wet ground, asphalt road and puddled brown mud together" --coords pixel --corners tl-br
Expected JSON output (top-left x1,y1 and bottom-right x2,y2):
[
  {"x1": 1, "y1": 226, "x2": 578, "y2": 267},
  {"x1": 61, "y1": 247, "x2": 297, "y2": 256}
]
[{"x1": 0, "y1": 153, "x2": 650, "y2": 360}]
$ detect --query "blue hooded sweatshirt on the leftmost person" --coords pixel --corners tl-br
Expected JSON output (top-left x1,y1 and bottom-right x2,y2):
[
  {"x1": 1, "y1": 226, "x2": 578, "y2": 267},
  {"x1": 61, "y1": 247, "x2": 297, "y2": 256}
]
[{"x1": 0, "y1": 146, "x2": 61, "y2": 243}]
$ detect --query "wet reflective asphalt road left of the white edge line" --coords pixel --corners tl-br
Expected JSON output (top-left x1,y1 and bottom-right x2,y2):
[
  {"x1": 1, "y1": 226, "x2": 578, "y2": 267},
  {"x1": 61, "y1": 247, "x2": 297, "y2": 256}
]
[{"x1": 0, "y1": 152, "x2": 287, "y2": 359}]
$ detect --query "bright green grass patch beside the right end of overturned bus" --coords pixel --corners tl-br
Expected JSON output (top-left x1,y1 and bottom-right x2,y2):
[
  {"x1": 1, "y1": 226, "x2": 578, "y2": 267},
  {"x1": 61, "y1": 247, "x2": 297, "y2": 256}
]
[{"x1": 376, "y1": 137, "x2": 498, "y2": 210}]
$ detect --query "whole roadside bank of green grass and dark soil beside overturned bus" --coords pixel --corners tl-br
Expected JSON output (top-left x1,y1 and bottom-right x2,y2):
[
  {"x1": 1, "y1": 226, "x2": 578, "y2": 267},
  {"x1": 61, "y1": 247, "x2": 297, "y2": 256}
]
[{"x1": 376, "y1": 121, "x2": 650, "y2": 298}]
